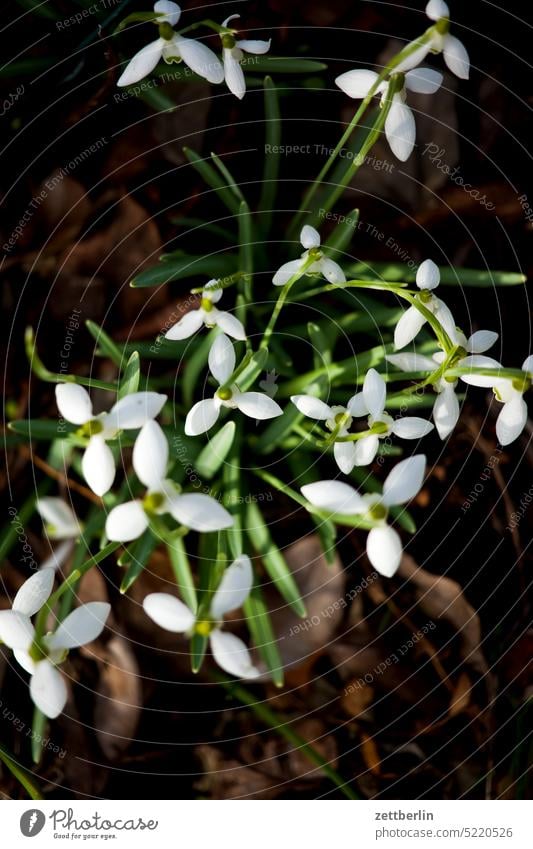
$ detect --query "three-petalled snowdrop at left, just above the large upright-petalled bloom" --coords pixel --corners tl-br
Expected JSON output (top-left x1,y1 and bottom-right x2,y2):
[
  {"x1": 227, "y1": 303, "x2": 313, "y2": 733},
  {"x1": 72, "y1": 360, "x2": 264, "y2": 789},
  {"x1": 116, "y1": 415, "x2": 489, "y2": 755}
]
[{"x1": 56, "y1": 383, "x2": 167, "y2": 496}]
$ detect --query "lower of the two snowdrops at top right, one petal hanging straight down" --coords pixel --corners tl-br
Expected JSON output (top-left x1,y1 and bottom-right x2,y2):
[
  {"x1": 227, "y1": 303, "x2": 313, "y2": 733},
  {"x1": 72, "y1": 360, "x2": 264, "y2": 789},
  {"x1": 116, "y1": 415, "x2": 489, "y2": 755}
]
[{"x1": 335, "y1": 68, "x2": 442, "y2": 162}]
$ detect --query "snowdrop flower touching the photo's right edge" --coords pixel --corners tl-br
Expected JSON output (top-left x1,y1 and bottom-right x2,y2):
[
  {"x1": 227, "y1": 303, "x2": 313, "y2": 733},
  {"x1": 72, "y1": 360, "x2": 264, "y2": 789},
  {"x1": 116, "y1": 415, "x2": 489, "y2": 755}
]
[{"x1": 461, "y1": 354, "x2": 533, "y2": 445}]
